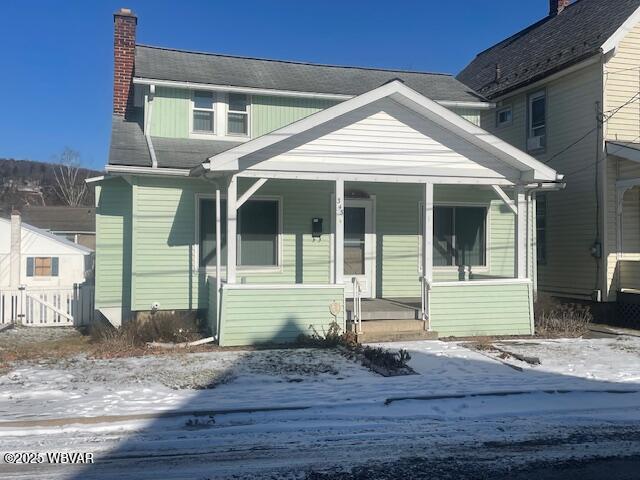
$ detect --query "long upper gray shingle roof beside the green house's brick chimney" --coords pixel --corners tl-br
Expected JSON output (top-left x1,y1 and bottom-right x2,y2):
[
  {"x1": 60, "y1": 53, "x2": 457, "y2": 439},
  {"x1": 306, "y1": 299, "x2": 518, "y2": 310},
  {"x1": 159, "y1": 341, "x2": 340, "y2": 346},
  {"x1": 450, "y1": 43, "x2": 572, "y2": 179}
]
[{"x1": 135, "y1": 45, "x2": 485, "y2": 102}]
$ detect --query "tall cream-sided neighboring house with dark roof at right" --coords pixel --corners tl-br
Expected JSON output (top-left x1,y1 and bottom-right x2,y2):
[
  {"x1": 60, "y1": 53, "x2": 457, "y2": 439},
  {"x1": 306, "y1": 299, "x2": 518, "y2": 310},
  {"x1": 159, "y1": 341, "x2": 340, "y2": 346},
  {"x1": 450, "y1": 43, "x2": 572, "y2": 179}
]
[{"x1": 457, "y1": 0, "x2": 640, "y2": 320}]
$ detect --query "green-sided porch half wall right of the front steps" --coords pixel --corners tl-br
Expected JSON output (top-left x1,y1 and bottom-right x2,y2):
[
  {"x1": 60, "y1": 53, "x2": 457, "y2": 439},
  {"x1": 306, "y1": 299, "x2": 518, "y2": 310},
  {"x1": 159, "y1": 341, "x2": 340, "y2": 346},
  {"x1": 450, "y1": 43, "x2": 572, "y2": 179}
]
[{"x1": 430, "y1": 283, "x2": 533, "y2": 337}]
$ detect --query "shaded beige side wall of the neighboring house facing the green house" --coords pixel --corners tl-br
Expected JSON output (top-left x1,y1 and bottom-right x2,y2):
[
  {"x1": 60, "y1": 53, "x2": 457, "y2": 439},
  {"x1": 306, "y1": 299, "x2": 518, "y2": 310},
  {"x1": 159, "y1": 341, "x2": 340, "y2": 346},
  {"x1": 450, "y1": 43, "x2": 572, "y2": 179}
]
[{"x1": 482, "y1": 64, "x2": 602, "y2": 296}]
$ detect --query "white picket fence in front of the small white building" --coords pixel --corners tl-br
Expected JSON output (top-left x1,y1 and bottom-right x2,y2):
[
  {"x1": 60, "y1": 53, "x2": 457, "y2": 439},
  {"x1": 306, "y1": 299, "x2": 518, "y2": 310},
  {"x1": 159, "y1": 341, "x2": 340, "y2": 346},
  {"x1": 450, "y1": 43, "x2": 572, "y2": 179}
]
[{"x1": 0, "y1": 284, "x2": 94, "y2": 327}]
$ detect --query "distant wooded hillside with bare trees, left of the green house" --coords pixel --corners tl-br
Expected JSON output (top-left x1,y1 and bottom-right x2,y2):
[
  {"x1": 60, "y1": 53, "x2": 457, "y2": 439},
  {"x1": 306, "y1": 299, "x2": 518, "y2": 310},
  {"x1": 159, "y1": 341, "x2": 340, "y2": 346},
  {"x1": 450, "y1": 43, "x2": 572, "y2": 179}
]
[{"x1": 0, "y1": 158, "x2": 103, "y2": 214}]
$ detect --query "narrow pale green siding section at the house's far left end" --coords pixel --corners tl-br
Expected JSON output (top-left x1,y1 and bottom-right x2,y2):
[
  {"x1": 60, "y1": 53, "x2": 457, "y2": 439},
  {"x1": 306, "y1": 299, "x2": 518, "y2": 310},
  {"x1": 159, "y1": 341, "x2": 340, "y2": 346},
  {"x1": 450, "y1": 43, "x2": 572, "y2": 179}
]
[{"x1": 95, "y1": 178, "x2": 131, "y2": 309}]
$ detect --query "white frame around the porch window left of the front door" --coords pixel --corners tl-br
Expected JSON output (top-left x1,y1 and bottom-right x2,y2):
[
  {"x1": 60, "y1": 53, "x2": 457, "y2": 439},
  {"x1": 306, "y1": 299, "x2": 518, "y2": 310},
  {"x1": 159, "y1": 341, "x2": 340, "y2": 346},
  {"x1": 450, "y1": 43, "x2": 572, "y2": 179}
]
[{"x1": 192, "y1": 193, "x2": 284, "y2": 276}]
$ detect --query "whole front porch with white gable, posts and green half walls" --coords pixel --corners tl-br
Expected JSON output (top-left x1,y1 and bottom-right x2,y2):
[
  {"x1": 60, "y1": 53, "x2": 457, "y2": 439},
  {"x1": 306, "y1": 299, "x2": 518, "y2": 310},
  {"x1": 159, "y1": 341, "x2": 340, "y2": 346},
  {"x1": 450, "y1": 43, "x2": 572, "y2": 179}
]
[{"x1": 193, "y1": 83, "x2": 557, "y2": 345}]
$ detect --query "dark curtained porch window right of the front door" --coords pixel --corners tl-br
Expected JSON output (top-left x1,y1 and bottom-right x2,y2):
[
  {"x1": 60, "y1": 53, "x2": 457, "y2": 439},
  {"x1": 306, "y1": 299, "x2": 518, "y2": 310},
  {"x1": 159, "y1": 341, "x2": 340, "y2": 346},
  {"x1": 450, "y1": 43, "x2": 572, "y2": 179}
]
[{"x1": 420, "y1": 206, "x2": 487, "y2": 267}]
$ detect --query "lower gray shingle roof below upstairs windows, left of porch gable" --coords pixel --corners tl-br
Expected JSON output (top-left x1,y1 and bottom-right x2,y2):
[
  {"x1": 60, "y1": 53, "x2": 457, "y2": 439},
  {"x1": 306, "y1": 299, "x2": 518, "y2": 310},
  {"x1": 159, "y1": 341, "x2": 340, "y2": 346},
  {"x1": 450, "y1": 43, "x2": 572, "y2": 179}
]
[{"x1": 109, "y1": 115, "x2": 240, "y2": 169}]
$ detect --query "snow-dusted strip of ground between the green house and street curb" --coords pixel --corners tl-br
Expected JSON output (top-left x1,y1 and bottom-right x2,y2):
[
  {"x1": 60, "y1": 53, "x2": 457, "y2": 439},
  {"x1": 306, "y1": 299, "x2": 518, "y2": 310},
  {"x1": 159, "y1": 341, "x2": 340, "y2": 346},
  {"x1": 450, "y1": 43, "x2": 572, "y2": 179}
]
[{"x1": 0, "y1": 337, "x2": 640, "y2": 421}]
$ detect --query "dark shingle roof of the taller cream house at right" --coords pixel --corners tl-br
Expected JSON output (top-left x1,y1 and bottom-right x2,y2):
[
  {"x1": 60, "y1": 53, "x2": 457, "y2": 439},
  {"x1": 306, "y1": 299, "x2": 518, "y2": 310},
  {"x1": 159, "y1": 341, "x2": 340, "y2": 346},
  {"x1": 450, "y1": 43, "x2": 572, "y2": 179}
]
[{"x1": 457, "y1": 0, "x2": 640, "y2": 99}]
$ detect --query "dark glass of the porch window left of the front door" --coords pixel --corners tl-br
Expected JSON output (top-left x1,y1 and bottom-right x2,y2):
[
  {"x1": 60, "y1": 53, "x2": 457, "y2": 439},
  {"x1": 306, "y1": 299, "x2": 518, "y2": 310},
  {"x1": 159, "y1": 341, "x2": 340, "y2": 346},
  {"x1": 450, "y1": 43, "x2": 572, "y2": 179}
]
[{"x1": 199, "y1": 198, "x2": 280, "y2": 267}]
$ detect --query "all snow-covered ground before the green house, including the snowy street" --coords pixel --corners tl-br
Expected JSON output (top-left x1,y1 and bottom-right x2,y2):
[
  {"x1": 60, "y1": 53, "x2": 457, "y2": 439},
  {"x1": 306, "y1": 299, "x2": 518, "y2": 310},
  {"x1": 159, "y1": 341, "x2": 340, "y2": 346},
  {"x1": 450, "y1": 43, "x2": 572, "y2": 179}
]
[{"x1": 0, "y1": 337, "x2": 640, "y2": 478}]
